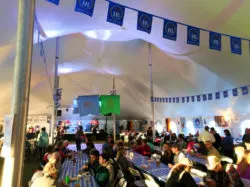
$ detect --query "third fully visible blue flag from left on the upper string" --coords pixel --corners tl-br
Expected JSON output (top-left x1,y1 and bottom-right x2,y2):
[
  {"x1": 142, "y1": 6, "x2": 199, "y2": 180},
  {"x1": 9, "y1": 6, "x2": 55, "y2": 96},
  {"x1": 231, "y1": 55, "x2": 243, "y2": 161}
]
[{"x1": 163, "y1": 19, "x2": 177, "y2": 41}]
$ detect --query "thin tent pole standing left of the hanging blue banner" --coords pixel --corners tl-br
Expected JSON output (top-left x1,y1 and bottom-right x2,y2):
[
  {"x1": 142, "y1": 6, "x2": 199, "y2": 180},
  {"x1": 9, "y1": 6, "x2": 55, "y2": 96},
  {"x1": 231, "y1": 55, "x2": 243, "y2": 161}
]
[{"x1": 51, "y1": 37, "x2": 59, "y2": 144}]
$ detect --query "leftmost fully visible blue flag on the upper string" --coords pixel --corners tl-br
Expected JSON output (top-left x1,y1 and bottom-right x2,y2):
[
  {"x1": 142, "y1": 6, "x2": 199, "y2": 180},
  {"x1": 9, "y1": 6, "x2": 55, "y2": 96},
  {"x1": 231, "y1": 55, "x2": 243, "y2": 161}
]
[{"x1": 107, "y1": 1, "x2": 125, "y2": 26}]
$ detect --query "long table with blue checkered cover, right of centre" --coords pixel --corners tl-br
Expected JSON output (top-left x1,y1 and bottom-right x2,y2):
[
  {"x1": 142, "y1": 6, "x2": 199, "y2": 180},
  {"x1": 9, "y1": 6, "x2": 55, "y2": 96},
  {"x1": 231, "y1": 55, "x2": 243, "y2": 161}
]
[{"x1": 128, "y1": 151, "x2": 203, "y2": 184}]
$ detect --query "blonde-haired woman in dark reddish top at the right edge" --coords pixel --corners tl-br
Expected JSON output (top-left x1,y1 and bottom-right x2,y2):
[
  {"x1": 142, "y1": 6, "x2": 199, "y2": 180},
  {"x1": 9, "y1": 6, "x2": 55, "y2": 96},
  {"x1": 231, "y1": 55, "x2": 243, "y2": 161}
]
[{"x1": 237, "y1": 150, "x2": 250, "y2": 180}]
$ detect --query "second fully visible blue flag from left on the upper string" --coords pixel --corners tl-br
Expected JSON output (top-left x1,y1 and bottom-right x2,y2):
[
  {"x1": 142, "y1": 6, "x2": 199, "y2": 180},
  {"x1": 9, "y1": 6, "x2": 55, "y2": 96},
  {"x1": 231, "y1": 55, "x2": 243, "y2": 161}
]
[{"x1": 137, "y1": 11, "x2": 153, "y2": 34}]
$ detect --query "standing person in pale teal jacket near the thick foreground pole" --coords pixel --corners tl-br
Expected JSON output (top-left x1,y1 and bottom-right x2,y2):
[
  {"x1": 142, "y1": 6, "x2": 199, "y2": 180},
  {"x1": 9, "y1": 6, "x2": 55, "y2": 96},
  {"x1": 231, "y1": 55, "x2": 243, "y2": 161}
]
[{"x1": 37, "y1": 127, "x2": 49, "y2": 160}]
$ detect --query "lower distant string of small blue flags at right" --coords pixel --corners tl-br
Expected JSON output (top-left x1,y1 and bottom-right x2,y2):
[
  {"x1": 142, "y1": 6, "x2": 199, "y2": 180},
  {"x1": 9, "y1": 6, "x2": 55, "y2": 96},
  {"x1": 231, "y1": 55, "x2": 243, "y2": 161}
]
[{"x1": 151, "y1": 85, "x2": 250, "y2": 103}]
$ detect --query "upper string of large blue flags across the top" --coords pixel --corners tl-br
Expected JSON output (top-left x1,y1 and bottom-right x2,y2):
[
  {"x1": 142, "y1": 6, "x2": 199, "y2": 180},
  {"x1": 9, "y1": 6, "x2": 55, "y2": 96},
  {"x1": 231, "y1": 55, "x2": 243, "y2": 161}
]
[{"x1": 47, "y1": 0, "x2": 250, "y2": 55}]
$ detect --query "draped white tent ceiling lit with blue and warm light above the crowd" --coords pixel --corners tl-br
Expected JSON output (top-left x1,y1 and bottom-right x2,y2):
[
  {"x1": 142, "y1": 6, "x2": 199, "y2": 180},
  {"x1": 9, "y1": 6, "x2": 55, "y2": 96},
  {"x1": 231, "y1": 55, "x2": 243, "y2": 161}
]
[{"x1": 0, "y1": 0, "x2": 250, "y2": 119}]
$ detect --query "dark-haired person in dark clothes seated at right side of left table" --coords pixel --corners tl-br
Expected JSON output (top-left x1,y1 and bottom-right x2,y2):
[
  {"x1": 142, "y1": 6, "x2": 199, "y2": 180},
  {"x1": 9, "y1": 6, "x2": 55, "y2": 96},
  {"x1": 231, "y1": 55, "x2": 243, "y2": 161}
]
[{"x1": 82, "y1": 149, "x2": 99, "y2": 174}]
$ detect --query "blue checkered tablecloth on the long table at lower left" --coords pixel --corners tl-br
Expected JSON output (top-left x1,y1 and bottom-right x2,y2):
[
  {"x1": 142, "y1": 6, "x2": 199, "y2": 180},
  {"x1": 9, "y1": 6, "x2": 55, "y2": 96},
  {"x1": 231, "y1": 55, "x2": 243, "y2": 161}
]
[{"x1": 59, "y1": 154, "x2": 98, "y2": 187}]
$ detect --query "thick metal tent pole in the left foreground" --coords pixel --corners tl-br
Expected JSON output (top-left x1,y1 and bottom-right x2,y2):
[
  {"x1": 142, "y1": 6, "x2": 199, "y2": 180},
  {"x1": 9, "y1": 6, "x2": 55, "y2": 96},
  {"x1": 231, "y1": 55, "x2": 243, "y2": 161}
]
[{"x1": 2, "y1": 0, "x2": 35, "y2": 187}]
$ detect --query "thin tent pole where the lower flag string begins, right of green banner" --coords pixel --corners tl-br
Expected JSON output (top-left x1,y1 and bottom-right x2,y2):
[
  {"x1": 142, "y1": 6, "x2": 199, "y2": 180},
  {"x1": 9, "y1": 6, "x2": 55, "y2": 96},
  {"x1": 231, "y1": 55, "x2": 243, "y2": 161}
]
[{"x1": 148, "y1": 43, "x2": 155, "y2": 141}]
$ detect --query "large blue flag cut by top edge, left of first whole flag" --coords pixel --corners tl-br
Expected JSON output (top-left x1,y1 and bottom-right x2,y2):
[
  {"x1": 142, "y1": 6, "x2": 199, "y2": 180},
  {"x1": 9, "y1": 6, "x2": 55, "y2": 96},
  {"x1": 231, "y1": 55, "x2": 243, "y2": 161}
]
[{"x1": 75, "y1": 0, "x2": 95, "y2": 17}]
